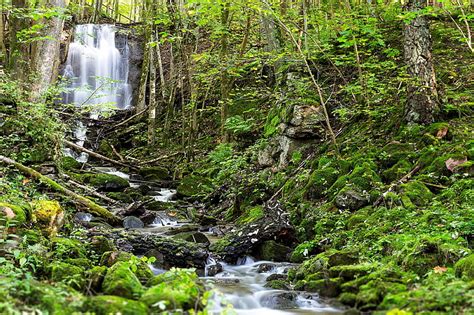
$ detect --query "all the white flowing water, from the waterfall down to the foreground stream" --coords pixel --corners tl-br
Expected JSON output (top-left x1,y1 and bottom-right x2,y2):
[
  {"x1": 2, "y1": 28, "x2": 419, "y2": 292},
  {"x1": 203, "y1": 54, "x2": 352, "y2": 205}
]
[{"x1": 63, "y1": 24, "x2": 342, "y2": 315}]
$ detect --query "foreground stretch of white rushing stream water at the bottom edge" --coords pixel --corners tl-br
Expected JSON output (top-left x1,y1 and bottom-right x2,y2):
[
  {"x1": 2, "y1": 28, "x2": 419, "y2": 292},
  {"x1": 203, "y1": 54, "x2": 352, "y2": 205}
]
[{"x1": 205, "y1": 257, "x2": 342, "y2": 315}]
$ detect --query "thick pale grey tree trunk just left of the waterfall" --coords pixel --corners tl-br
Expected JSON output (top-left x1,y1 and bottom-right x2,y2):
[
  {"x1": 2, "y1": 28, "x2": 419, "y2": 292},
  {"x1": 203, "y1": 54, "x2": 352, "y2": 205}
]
[{"x1": 29, "y1": 0, "x2": 66, "y2": 102}]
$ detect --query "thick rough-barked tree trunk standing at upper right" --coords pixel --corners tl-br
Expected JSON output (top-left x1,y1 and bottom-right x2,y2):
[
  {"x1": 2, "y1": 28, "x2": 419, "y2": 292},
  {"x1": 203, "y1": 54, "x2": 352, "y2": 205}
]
[{"x1": 404, "y1": 0, "x2": 438, "y2": 124}]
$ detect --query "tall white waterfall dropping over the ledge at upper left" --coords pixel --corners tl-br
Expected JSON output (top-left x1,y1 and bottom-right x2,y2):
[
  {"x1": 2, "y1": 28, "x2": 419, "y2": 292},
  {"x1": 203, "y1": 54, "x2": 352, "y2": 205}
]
[{"x1": 63, "y1": 24, "x2": 132, "y2": 112}]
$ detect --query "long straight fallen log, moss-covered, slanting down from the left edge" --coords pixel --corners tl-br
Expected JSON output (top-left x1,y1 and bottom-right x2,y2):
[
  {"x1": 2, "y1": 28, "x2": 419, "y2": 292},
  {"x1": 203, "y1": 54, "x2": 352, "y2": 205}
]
[{"x1": 0, "y1": 155, "x2": 121, "y2": 225}]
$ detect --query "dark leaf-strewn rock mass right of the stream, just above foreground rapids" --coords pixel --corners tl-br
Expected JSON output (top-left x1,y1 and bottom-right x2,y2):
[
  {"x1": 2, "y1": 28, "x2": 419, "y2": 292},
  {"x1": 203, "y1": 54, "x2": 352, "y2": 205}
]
[{"x1": 210, "y1": 203, "x2": 295, "y2": 263}]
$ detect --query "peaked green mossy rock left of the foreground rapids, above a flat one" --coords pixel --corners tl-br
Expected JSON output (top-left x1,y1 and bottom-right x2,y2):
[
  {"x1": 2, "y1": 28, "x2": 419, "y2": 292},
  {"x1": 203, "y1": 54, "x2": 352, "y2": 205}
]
[{"x1": 102, "y1": 261, "x2": 143, "y2": 299}]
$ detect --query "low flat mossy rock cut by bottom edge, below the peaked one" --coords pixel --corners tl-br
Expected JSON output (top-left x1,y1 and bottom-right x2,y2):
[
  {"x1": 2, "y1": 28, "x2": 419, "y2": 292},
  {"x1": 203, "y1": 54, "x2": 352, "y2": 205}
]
[{"x1": 83, "y1": 295, "x2": 148, "y2": 315}]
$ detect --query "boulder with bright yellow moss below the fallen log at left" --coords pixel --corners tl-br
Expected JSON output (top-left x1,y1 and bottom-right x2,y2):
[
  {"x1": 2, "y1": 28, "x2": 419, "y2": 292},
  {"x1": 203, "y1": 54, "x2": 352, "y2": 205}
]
[{"x1": 31, "y1": 200, "x2": 64, "y2": 236}]
